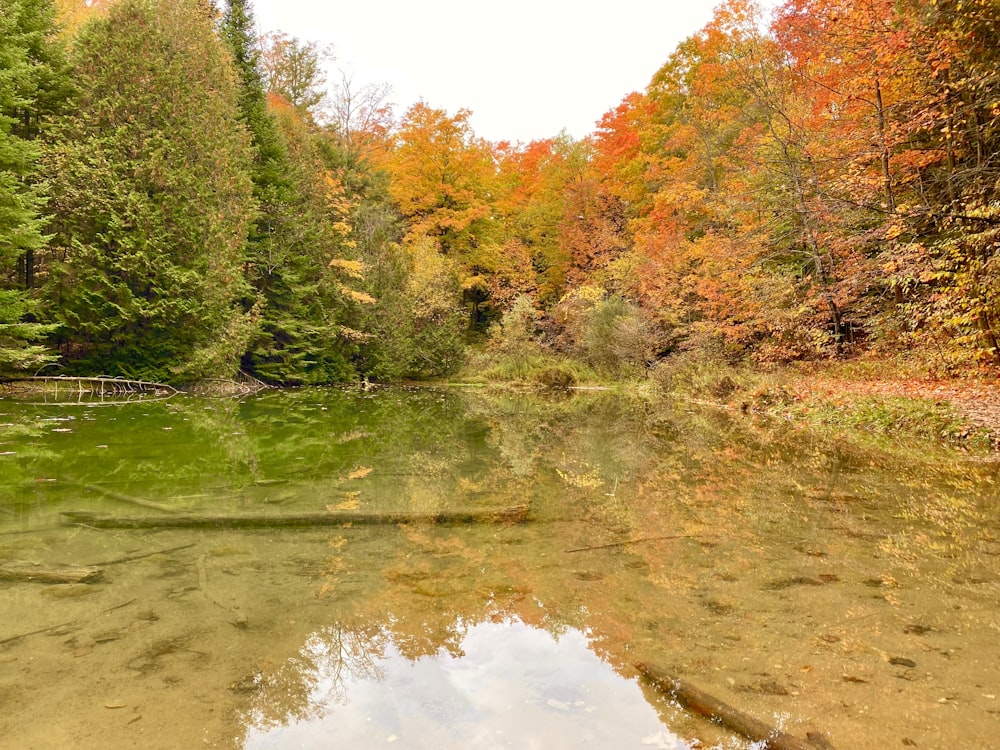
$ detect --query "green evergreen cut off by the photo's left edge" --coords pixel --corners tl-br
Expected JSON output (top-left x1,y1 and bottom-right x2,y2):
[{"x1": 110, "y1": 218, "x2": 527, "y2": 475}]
[{"x1": 0, "y1": 0, "x2": 69, "y2": 370}]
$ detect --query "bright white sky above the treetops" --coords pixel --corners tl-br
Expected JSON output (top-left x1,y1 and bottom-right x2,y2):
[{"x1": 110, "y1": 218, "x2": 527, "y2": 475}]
[{"x1": 253, "y1": 0, "x2": 718, "y2": 142}]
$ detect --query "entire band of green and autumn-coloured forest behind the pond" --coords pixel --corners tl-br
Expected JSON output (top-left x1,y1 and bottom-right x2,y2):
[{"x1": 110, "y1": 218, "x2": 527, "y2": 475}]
[{"x1": 0, "y1": 0, "x2": 1000, "y2": 385}]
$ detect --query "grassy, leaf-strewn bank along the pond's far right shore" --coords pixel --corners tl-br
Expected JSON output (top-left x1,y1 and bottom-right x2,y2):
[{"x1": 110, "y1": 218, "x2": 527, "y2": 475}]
[{"x1": 457, "y1": 350, "x2": 1000, "y2": 453}]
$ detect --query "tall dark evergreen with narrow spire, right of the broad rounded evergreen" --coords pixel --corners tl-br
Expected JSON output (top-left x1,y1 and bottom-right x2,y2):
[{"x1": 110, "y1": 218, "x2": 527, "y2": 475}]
[{"x1": 221, "y1": 0, "x2": 363, "y2": 384}]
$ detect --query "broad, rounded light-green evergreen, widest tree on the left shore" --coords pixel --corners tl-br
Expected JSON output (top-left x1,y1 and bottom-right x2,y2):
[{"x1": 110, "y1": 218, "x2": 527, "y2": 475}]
[{"x1": 48, "y1": 0, "x2": 255, "y2": 381}]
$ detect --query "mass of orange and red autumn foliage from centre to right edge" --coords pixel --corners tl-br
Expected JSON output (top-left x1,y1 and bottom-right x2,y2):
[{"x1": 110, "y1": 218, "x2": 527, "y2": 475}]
[{"x1": 366, "y1": 0, "x2": 1000, "y2": 370}]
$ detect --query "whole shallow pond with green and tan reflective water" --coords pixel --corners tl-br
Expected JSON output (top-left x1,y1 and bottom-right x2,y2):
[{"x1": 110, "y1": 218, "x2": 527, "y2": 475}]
[{"x1": 0, "y1": 388, "x2": 1000, "y2": 750}]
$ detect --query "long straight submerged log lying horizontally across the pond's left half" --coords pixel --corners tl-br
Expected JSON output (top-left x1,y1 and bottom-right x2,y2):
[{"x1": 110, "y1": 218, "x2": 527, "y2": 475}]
[{"x1": 59, "y1": 505, "x2": 528, "y2": 529}]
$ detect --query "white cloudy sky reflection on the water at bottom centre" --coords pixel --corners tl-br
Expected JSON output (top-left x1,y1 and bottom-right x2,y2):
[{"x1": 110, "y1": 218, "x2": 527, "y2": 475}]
[{"x1": 245, "y1": 620, "x2": 689, "y2": 750}]
